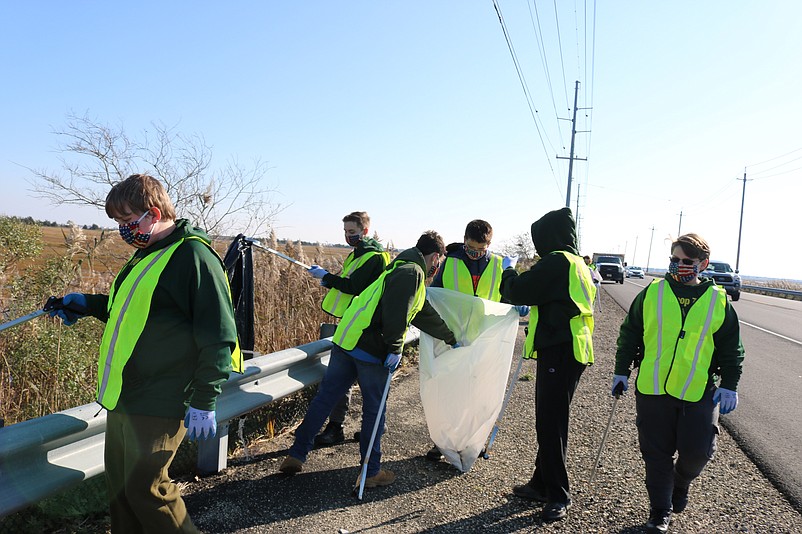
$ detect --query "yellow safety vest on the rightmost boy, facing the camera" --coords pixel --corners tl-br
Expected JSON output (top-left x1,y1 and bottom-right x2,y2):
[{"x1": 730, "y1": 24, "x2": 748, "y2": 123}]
[{"x1": 637, "y1": 279, "x2": 727, "y2": 402}]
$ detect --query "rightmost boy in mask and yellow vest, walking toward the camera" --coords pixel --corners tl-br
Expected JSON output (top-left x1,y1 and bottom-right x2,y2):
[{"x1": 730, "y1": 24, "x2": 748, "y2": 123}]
[{"x1": 613, "y1": 234, "x2": 744, "y2": 532}]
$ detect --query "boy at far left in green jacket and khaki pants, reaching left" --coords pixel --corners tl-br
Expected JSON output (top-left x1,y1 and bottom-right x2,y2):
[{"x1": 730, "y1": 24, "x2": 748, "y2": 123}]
[{"x1": 48, "y1": 174, "x2": 241, "y2": 533}]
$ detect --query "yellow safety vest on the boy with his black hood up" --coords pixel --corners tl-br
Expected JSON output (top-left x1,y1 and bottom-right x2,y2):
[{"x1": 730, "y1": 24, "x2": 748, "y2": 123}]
[{"x1": 523, "y1": 250, "x2": 596, "y2": 365}]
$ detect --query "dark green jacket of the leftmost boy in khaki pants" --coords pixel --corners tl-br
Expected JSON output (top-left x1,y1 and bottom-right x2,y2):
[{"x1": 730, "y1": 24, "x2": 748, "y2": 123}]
[{"x1": 86, "y1": 219, "x2": 237, "y2": 418}]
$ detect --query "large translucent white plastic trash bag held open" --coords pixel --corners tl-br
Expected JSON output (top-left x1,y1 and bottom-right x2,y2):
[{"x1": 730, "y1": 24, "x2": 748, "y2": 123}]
[{"x1": 420, "y1": 287, "x2": 520, "y2": 473}]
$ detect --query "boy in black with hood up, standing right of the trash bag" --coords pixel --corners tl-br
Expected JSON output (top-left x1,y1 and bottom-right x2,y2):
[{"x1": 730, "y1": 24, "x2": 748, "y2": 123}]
[{"x1": 501, "y1": 208, "x2": 596, "y2": 521}]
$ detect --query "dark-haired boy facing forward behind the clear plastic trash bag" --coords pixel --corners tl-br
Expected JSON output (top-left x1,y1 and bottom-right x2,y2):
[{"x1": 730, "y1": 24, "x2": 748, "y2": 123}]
[{"x1": 426, "y1": 219, "x2": 529, "y2": 462}]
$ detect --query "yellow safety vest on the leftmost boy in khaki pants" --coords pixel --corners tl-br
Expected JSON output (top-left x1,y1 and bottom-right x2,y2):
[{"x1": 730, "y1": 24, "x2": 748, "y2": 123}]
[{"x1": 97, "y1": 236, "x2": 243, "y2": 410}]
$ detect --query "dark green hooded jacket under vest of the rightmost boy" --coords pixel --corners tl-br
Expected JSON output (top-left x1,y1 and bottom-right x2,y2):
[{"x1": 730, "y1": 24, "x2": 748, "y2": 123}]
[{"x1": 615, "y1": 274, "x2": 744, "y2": 391}]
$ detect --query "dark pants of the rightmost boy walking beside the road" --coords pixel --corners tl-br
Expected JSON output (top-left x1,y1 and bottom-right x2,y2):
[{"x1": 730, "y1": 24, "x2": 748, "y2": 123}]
[{"x1": 635, "y1": 386, "x2": 718, "y2": 510}]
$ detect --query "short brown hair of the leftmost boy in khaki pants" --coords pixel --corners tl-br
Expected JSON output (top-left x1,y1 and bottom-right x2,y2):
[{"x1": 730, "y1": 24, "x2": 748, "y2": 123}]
[{"x1": 106, "y1": 174, "x2": 175, "y2": 221}]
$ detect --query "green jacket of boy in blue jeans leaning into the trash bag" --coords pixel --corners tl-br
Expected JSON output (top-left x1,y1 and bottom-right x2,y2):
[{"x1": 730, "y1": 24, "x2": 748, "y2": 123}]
[{"x1": 346, "y1": 247, "x2": 457, "y2": 361}]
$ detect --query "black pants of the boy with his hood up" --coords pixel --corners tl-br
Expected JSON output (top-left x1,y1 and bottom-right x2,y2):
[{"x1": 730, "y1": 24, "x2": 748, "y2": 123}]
[{"x1": 529, "y1": 343, "x2": 585, "y2": 503}]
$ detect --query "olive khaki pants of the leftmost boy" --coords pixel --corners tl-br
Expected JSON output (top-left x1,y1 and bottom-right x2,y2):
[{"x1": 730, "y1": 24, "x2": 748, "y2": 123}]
[{"x1": 104, "y1": 411, "x2": 199, "y2": 534}]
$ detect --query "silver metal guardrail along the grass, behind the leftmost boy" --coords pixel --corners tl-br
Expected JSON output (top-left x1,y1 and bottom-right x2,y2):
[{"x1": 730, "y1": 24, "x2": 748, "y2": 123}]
[{"x1": 0, "y1": 328, "x2": 420, "y2": 517}]
